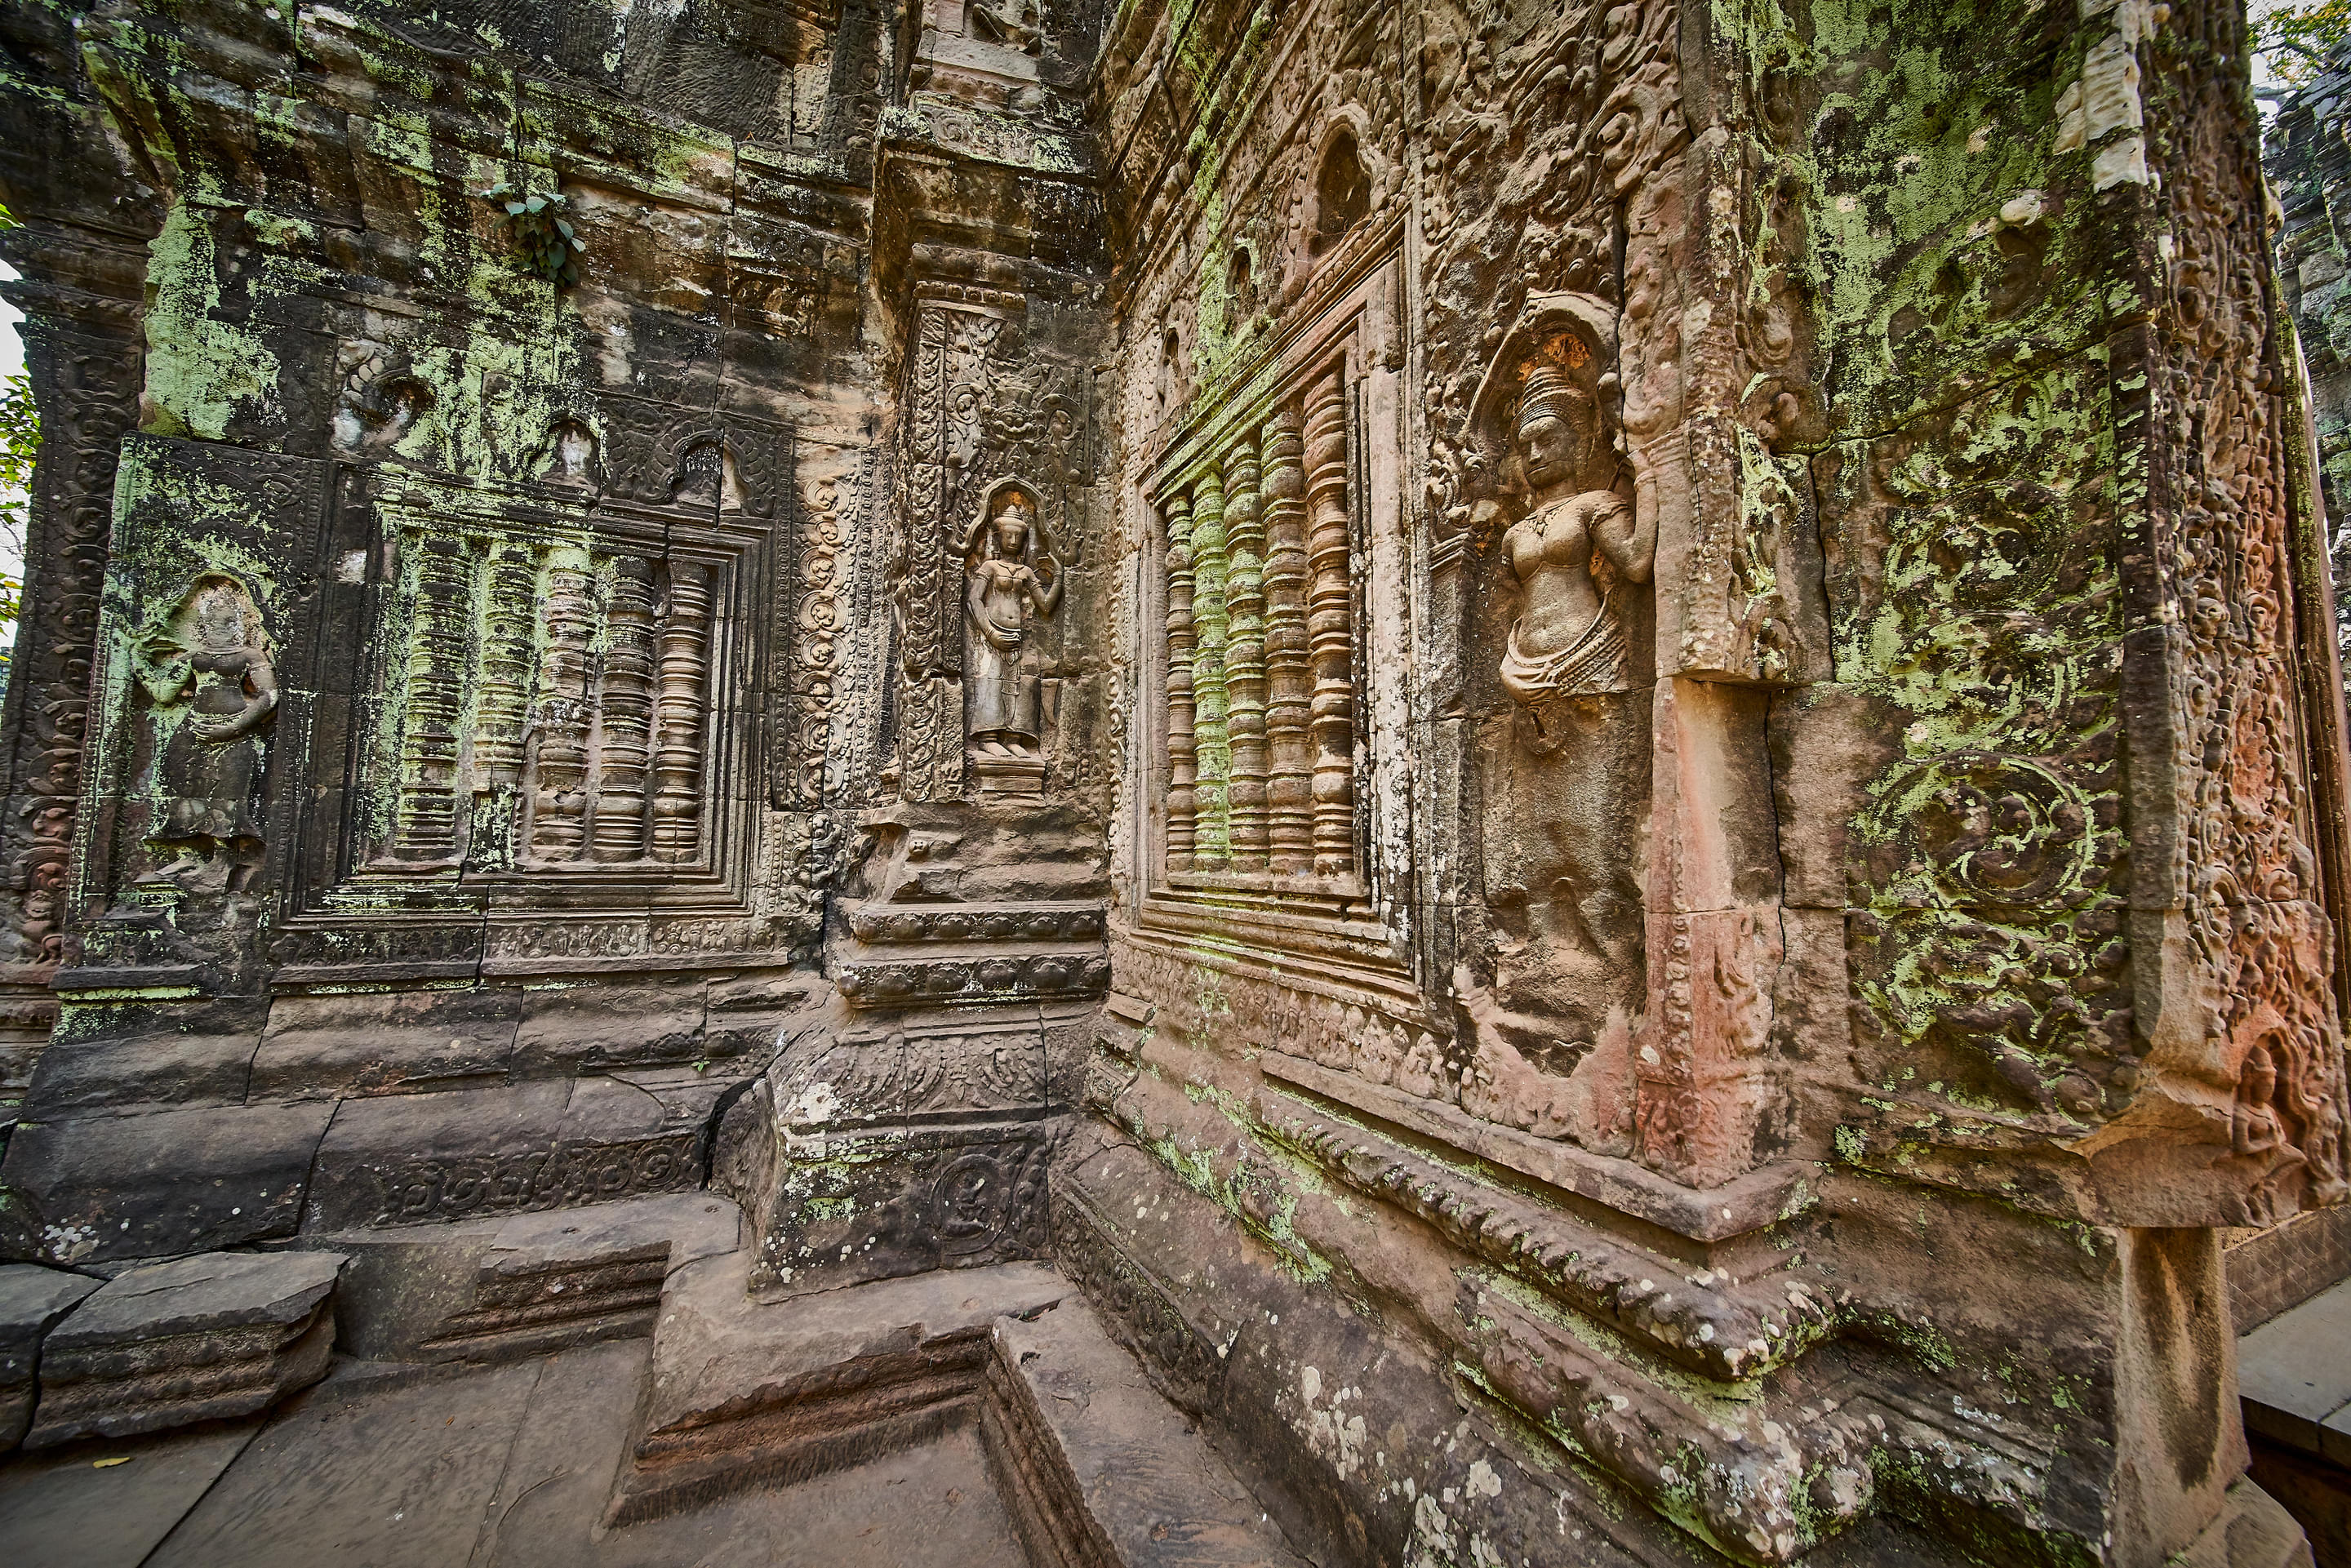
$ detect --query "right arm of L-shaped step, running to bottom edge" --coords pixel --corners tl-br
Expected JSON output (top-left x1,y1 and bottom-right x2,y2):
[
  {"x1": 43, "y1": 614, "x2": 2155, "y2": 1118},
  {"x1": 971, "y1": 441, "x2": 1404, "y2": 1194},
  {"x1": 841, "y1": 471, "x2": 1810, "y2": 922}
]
[{"x1": 980, "y1": 1295, "x2": 1304, "y2": 1568}]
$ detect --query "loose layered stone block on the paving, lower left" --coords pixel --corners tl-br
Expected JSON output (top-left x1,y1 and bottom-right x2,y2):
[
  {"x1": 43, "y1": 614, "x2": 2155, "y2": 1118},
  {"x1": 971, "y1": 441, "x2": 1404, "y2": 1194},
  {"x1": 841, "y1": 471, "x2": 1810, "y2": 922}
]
[{"x1": 24, "y1": 1253, "x2": 343, "y2": 1448}]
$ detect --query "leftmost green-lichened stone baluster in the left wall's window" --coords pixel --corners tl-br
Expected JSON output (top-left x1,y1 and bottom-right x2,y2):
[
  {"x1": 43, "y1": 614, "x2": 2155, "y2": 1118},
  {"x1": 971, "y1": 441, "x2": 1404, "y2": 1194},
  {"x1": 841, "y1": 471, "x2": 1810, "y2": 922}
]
[{"x1": 393, "y1": 531, "x2": 480, "y2": 863}]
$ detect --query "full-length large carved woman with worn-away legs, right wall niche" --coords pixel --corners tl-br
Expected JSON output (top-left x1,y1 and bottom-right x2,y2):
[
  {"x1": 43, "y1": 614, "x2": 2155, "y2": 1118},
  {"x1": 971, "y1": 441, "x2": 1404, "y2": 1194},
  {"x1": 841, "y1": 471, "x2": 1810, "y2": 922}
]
[{"x1": 1458, "y1": 294, "x2": 1657, "y2": 1128}]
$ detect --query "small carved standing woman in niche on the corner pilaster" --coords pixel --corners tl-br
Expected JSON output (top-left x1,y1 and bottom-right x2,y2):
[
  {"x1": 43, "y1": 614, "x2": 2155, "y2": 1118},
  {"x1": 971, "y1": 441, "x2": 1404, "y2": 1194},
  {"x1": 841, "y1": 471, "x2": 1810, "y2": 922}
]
[{"x1": 964, "y1": 489, "x2": 1060, "y2": 785}]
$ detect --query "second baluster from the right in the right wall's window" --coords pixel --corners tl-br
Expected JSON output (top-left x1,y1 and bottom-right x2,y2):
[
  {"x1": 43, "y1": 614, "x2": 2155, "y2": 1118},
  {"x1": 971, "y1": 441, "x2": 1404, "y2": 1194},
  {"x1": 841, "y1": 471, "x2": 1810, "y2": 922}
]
[{"x1": 1260, "y1": 402, "x2": 1314, "y2": 874}]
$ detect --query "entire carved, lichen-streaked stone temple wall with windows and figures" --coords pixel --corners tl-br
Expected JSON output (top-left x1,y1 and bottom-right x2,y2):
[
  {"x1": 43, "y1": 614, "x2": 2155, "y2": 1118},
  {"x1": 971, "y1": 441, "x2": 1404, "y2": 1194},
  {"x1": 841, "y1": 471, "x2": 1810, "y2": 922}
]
[{"x1": 0, "y1": 0, "x2": 2351, "y2": 1563}]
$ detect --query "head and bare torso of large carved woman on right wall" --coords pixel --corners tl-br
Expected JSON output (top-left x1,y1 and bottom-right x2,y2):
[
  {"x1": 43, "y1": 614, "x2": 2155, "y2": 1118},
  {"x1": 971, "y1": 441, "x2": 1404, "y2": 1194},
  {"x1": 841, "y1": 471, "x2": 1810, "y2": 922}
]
[{"x1": 1500, "y1": 331, "x2": 1657, "y2": 734}]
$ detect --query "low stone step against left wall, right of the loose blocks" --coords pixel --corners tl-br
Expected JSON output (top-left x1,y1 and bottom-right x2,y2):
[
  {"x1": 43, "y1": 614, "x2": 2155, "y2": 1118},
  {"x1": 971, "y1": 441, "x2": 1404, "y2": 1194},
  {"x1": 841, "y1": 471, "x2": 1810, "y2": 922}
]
[{"x1": 301, "y1": 1192, "x2": 743, "y2": 1361}]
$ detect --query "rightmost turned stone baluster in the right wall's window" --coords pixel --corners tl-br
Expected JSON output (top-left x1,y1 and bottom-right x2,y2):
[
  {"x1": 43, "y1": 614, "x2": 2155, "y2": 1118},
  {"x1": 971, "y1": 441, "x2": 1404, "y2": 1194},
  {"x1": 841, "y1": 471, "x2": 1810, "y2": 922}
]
[{"x1": 1304, "y1": 366, "x2": 1354, "y2": 877}]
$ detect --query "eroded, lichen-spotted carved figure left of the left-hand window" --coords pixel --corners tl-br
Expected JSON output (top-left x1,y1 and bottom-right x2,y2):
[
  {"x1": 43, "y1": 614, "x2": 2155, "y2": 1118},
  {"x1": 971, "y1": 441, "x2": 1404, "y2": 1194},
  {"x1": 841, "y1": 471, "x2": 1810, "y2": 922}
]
[{"x1": 141, "y1": 578, "x2": 278, "y2": 891}]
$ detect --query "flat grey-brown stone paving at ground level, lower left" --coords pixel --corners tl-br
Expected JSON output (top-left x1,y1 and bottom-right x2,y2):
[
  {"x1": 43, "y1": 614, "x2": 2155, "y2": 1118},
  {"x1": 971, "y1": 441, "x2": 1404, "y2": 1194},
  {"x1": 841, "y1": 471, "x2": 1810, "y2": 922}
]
[{"x1": 0, "y1": 1340, "x2": 1028, "y2": 1568}]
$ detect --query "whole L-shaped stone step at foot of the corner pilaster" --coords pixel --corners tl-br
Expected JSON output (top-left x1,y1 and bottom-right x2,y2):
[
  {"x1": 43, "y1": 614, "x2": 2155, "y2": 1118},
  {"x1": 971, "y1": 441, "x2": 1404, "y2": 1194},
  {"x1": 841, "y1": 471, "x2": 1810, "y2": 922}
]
[{"x1": 604, "y1": 1250, "x2": 1304, "y2": 1568}]
